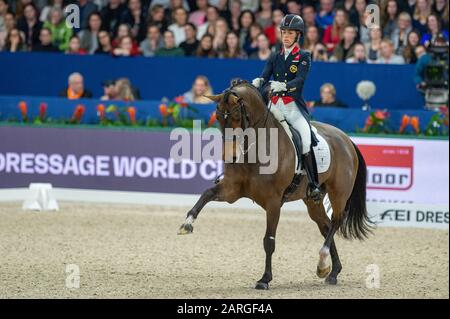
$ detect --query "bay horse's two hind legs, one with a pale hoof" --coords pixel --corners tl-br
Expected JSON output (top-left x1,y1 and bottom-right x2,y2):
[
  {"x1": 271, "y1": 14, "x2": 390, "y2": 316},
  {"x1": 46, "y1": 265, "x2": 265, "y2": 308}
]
[{"x1": 305, "y1": 201, "x2": 342, "y2": 284}]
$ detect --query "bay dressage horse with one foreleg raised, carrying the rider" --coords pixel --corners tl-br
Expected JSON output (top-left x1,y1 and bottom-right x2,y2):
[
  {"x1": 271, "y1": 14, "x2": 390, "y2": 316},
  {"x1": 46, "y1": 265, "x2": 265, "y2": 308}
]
[{"x1": 178, "y1": 81, "x2": 373, "y2": 289}]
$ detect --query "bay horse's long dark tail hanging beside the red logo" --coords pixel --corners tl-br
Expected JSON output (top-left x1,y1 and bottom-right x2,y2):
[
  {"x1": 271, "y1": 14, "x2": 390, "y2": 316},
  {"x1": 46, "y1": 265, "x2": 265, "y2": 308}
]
[{"x1": 339, "y1": 143, "x2": 374, "y2": 240}]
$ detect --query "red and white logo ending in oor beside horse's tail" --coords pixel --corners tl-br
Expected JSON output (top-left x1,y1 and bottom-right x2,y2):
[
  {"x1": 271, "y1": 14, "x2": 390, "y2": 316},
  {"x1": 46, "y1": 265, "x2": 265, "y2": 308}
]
[{"x1": 358, "y1": 145, "x2": 414, "y2": 191}]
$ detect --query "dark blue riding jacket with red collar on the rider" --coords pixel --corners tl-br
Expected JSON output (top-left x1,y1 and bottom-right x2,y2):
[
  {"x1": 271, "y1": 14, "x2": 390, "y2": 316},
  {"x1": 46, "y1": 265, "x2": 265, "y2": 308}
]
[{"x1": 261, "y1": 45, "x2": 311, "y2": 119}]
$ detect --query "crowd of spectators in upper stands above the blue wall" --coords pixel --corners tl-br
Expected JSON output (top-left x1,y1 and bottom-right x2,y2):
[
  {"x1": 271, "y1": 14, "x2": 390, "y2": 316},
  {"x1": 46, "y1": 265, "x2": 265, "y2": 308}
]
[{"x1": 0, "y1": 0, "x2": 449, "y2": 64}]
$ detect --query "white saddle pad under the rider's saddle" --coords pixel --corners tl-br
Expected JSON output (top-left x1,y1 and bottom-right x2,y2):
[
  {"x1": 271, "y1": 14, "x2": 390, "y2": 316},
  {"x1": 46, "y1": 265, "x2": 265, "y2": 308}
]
[{"x1": 270, "y1": 107, "x2": 331, "y2": 174}]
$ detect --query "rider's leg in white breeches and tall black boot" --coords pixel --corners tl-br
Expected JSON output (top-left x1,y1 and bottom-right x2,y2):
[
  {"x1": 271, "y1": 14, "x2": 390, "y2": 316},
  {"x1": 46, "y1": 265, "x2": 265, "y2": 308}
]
[{"x1": 285, "y1": 103, "x2": 323, "y2": 202}]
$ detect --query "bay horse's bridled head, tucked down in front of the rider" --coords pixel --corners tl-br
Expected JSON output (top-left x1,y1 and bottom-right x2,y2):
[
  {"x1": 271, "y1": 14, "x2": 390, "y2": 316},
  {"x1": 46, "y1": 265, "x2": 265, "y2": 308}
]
[{"x1": 207, "y1": 81, "x2": 267, "y2": 162}]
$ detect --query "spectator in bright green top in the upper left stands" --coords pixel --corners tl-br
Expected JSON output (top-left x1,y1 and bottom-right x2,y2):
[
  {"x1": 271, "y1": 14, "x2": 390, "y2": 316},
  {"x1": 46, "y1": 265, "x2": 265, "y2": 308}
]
[{"x1": 44, "y1": 8, "x2": 73, "y2": 52}]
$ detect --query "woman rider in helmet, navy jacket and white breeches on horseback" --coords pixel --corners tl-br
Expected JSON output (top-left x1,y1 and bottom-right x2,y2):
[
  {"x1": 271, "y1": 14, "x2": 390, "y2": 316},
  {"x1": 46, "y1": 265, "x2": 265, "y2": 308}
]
[{"x1": 253, "y1": 14, "x2": 322, "y2": 202}]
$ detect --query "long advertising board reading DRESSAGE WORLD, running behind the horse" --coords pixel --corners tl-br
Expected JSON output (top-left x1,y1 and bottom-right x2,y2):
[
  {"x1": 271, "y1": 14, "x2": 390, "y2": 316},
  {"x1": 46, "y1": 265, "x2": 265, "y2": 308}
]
[{"x1": 0, "y1": 127, "x2": 449, "y2": 207}]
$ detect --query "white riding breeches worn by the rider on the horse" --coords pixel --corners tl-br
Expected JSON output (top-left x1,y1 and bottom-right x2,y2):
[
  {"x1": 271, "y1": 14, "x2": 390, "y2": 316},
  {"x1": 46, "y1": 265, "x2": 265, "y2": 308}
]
[{"x1": 273, "y1": 98, "x2": 311, "y2": 154}]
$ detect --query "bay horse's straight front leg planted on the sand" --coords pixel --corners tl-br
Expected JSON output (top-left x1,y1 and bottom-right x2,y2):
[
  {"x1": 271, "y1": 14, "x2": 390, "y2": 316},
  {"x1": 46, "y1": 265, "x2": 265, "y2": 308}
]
[{"x1": 255, "y1": 201, "x2": 280, "y2": 290}]
